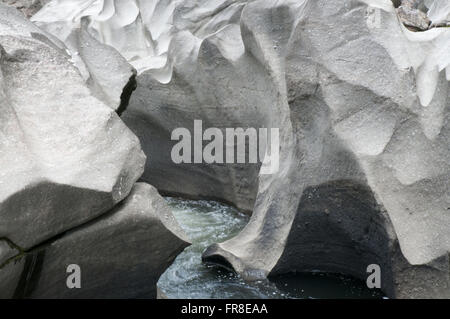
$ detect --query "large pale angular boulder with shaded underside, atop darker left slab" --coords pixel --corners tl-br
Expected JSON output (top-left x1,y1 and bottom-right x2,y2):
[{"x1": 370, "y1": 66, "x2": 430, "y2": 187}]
[{"x1": 0, "y1": 4, "x2": 145, "y2": 249}]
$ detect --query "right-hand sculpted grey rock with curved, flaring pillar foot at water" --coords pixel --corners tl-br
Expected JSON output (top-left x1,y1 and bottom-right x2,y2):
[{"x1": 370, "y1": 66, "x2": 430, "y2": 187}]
[{"x1": 203, "y1": 1, "x2": 450, "y2": 298}]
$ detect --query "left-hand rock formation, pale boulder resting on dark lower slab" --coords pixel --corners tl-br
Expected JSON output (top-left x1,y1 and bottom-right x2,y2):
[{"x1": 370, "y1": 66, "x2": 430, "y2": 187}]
[{"x1": 0, "y1": 4, "x2": 187, "y2": 298}]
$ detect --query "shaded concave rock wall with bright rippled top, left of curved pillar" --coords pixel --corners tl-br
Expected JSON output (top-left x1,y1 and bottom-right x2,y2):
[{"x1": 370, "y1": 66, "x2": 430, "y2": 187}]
[{"x1": 33, "y1": 0, "x2": 260, "y2": 215}]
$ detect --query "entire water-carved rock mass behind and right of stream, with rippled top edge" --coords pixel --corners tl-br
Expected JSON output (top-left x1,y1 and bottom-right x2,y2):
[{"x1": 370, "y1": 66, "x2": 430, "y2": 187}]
[{"x1": 7, "y1": 0, "x2": 450, "y2": 298}]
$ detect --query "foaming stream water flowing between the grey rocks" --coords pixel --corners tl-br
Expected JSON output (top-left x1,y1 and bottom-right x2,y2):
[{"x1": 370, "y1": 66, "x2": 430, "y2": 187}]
[{"x1": 158, "y1": 197, "x2": 382, "y2": 299}]
